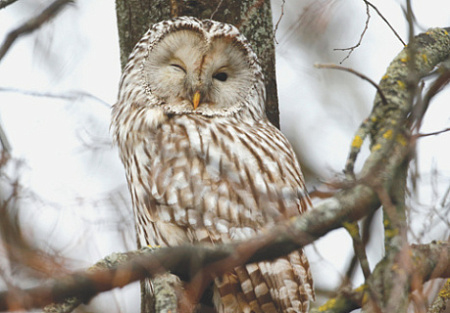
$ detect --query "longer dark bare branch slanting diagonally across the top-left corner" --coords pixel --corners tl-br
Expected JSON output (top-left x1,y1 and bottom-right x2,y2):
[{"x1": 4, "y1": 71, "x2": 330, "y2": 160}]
[{"x1": 0, "y1": 0, "x2": 73, "y2": 60}]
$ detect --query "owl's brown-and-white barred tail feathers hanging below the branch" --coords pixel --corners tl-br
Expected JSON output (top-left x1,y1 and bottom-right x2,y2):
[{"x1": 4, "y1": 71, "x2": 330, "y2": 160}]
[{"x1": 214, "y1": 251, "x2": 314, "y2": 313}]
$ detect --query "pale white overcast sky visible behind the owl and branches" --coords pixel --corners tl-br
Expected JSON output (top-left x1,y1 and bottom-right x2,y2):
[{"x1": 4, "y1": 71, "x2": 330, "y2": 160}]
[{"x1": 0, "y1": 0, "x2": 450, "y2": 312}]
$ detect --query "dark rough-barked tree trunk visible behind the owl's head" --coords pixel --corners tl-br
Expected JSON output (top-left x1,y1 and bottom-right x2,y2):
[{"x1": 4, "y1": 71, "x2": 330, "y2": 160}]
[{"x1": 116, "y1": 0, "x2": 280, "y2": 128}]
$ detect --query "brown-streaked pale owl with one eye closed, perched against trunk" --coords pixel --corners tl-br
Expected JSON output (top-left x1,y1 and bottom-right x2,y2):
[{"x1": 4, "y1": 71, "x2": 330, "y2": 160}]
[{"x1": 111, "y1": 17, "x2": 314, "y2": 313}]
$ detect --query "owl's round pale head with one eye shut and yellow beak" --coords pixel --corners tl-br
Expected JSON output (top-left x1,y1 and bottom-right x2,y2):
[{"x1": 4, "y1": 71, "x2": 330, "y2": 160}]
[{"x1": 119, "y1": 17, "x2": 265, "y2": 119}]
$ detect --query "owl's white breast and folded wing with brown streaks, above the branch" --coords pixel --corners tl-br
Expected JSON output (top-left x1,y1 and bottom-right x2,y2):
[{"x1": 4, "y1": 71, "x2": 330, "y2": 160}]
[{"x1": 127, "y1": 115, "x2": 305, "y2": 245}]
